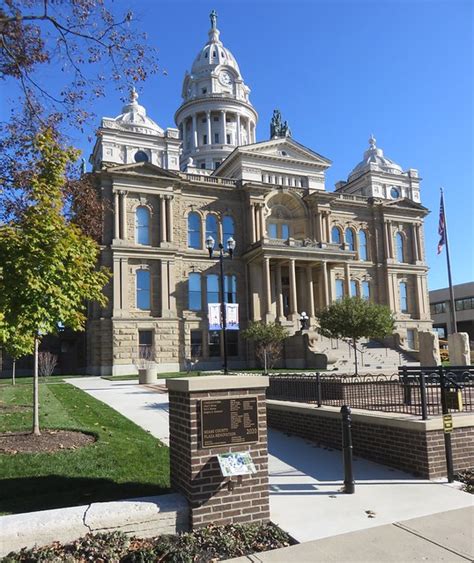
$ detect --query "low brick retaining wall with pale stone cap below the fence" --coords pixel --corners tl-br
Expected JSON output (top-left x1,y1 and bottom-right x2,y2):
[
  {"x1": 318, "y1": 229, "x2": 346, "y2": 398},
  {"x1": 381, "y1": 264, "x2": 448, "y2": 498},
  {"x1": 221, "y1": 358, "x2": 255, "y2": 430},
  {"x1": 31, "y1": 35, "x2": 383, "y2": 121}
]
[{"x1": 267, "y1": 400, "x2": 474, "y2": 479}]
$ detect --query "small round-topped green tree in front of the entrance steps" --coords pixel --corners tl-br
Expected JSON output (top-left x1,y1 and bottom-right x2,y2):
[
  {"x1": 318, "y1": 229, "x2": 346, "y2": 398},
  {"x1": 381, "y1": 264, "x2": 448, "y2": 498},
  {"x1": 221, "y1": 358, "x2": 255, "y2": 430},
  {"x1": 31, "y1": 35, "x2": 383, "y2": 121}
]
[{"x1": 316, "y1": 297, "x2": 394, "y2": 375}]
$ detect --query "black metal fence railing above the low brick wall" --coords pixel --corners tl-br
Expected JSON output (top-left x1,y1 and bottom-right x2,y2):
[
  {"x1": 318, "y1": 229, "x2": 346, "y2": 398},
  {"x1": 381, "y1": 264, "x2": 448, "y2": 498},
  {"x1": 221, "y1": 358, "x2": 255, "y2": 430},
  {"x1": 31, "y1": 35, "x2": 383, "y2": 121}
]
[{"x1": 267, "y1": 366, "x2": 474, "y2": 419}]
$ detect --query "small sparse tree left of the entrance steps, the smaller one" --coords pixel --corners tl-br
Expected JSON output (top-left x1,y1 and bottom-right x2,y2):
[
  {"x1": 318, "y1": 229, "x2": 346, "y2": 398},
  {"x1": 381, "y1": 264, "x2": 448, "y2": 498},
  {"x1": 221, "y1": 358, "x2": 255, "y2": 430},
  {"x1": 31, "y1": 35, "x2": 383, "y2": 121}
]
[{"x1": 242, "y1": 321, "x2": 288, "y2": 373}]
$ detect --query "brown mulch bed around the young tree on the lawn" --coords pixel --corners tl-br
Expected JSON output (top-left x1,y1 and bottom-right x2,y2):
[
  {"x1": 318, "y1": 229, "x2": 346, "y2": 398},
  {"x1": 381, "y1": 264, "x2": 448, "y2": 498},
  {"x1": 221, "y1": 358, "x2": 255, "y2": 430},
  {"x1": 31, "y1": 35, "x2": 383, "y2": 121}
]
[{"x1": 0, "y1": 430, "x2": 96, "y2": 455}]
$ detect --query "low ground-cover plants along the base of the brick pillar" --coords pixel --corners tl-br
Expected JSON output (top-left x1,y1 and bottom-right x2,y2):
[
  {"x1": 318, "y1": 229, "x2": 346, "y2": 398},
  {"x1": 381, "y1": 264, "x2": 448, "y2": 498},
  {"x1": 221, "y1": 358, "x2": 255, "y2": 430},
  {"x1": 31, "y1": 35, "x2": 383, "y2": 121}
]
[{"x1": 3, "y1": 524, "x2": 292, "y2": 563}]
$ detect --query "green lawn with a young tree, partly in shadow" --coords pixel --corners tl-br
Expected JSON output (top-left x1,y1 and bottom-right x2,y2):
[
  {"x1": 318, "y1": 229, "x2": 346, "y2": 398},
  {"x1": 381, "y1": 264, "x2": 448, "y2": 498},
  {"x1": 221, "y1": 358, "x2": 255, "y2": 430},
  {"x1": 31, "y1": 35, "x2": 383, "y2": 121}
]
[{"x1": 0, "y1": 383, "x2": 169, "y2": 513}]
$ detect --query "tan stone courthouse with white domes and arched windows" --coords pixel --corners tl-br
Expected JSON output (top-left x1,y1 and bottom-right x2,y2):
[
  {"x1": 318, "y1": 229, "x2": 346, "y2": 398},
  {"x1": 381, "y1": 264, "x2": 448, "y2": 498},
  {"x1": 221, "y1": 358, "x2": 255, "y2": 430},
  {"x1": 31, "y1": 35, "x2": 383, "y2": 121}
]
[{"x1": 87, "y1": 12, "x2": 432, "y2": 374}]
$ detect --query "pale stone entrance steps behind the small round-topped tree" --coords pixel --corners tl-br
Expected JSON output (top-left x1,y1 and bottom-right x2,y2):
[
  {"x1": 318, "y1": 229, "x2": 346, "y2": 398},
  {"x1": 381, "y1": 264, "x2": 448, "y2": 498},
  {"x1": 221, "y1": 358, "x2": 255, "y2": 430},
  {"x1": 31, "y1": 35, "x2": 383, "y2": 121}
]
[{"x1": 311, "y1": 334, "x2": 419, "y2": 373}]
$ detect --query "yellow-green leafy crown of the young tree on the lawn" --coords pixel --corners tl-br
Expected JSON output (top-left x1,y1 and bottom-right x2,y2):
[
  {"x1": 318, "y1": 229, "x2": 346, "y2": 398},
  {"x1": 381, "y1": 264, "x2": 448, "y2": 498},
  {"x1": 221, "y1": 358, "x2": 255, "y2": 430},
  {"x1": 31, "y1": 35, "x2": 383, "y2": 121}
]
[{"x1": 0, "y1": 130, "x2": 109, "y2": 354}]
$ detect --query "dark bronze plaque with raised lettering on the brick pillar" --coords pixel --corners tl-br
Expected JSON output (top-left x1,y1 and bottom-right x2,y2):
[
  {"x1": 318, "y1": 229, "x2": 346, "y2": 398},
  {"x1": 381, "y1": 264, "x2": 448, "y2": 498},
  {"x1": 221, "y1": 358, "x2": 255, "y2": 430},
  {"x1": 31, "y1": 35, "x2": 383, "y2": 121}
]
[{"x1": 201, "y1": 397, "x2": 258, "y2": 448}]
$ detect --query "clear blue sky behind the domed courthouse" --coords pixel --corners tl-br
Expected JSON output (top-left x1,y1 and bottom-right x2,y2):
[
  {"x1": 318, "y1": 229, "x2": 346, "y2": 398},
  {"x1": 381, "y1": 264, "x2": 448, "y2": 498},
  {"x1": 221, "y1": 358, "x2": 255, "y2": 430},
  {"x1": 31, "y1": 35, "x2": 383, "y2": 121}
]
[{"x1": 1, "y1": 0, "x2": 474, "y2": 289}]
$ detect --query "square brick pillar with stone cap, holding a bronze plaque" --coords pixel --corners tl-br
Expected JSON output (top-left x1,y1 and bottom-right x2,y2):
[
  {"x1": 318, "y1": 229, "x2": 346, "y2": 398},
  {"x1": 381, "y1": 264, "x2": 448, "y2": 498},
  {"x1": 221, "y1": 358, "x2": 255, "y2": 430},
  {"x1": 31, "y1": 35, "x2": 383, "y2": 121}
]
[{"x1": 166, "y1": 376, "x2": 270, "y2": 529}]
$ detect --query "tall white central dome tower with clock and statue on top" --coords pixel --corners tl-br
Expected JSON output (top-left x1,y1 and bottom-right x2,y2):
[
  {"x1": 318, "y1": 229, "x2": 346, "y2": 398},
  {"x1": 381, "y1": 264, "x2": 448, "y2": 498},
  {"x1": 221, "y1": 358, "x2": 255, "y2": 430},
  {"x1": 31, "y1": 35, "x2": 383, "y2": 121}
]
[{"x1": 175, "y1": 10, "x2": 258, "y2": 172}]
